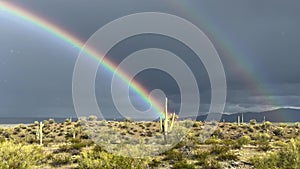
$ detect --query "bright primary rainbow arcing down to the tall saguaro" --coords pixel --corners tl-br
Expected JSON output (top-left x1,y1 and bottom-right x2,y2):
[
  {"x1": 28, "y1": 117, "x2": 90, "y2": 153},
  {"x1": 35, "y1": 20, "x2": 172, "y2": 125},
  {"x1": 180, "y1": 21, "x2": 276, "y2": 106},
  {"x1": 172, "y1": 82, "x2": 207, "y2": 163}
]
[{"x1": 0, "y1": 1, "x2": 164, "y2": 117}]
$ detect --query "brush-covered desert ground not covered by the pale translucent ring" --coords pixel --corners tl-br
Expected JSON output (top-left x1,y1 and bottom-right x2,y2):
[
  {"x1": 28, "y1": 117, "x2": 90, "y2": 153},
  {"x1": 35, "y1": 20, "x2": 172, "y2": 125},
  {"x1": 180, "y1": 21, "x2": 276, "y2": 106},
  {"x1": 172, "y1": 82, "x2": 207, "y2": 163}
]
[{"x1": 0, "y1": 118, "x2": 300, "y2": 169}]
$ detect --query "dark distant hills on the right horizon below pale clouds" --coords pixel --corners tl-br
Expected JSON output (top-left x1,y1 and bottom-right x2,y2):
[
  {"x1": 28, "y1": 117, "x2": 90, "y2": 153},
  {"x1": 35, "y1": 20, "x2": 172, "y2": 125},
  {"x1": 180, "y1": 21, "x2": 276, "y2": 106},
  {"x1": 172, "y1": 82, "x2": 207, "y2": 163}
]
[{"x1": 197, "y1": 108, "x2": 300, "y2": 122}]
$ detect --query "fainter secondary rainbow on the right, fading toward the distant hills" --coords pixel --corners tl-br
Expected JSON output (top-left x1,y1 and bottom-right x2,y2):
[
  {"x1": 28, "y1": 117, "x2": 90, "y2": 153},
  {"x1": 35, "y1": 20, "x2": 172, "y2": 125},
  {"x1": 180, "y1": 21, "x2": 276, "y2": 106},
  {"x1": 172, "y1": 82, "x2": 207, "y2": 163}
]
[{"x1": 168, "y1": 1, "x2": 298, "y2": 121}]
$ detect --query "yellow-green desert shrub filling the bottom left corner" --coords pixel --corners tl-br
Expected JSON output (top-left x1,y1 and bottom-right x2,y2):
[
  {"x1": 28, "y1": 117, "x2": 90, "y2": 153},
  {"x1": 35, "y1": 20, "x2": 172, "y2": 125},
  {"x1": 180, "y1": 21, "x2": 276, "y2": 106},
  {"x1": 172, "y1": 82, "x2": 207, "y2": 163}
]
[{"x1": 0, "y1": 141, "x2": 44, "y2": 169}]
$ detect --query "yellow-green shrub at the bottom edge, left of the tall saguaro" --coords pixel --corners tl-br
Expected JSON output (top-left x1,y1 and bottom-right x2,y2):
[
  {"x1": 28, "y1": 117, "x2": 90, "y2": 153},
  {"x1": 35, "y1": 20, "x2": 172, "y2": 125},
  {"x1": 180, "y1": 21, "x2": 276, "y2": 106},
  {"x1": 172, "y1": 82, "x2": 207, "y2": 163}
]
[{"x1": 78, "y1": 151, "x2": 148, "y2": 169}]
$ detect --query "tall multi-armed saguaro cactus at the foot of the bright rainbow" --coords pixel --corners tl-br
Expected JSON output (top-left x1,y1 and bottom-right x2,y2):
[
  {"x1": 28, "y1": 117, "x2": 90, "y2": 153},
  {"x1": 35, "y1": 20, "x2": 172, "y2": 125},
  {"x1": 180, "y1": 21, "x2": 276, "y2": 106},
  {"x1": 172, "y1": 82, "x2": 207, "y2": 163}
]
[{"x1": 159, "y1": 98, "x2": 176, "y2": 142}]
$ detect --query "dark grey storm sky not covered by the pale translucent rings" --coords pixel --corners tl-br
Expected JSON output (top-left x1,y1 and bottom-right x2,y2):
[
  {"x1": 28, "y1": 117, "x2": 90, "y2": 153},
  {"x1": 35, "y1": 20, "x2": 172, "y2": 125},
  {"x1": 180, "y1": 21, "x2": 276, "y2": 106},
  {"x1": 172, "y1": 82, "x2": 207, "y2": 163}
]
[{"x1": 0, "y1": 0, "x2": 300, "y2": 117}]
